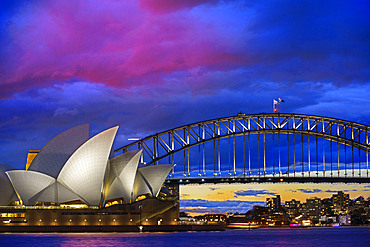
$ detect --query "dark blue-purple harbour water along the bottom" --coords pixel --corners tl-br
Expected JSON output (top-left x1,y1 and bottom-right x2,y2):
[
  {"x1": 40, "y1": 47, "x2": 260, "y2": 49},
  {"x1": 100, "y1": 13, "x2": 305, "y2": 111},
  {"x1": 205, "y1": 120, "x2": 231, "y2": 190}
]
[{"x1": 0, "y1": 227, "x2": 370, "y2": 247}]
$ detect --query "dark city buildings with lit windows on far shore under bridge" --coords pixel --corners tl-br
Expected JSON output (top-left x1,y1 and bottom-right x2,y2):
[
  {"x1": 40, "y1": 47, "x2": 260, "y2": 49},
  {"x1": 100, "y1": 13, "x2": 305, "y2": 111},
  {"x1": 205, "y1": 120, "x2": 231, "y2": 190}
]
[{"x1": 188, "y1": 191, "x2": 370, "y2": 223}]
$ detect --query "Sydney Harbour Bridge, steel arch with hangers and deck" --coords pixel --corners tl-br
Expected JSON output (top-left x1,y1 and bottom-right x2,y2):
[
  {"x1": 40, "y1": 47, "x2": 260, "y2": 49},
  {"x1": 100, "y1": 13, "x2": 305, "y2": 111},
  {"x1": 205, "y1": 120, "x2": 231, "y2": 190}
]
[{"x1": 115, "y1": 113, "x2": 370, "y2": 184}]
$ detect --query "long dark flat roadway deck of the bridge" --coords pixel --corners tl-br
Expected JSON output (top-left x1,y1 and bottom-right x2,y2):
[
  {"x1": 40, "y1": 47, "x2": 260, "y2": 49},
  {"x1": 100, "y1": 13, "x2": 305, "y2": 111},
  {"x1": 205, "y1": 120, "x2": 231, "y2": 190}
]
[{"x1": 166, "y1": 176, "x2": 370, "y2": 185}]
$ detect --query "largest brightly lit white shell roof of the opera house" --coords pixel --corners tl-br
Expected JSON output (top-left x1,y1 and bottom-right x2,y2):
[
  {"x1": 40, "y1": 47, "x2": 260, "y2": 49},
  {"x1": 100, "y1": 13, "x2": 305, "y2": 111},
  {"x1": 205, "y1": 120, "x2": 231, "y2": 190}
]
[{"x1": 57, "y1": 126, "x2": 118, "y2": 206}]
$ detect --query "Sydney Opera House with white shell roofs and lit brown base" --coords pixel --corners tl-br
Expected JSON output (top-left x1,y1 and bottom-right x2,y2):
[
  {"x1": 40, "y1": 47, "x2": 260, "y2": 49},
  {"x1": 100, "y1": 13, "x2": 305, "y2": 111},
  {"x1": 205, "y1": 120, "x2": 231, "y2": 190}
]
[{"x1": 0, "y1": 124, "x2": 179, "y2": 230}]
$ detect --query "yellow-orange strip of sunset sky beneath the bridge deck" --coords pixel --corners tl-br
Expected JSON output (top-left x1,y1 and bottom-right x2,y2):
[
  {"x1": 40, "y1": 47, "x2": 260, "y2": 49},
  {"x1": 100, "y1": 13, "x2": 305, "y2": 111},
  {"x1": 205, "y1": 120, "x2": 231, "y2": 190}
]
[{"x1": 180, "y1": 183, "x2": 370, "y2": 215}]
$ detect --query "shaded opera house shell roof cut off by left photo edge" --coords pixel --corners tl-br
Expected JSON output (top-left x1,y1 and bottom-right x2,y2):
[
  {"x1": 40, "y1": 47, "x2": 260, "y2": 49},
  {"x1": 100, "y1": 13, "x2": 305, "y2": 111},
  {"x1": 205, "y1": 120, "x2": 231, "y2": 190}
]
[{"x1": 0, "y1": 163, "x2": 18, "y2": 206}]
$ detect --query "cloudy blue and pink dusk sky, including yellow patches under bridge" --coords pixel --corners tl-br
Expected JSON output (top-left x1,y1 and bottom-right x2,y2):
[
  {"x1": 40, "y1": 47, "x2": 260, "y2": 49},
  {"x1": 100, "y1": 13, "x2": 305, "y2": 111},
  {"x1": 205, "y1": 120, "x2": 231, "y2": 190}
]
[{"x1": 0, "y1": 0, "x2": 370, "y2": 214}]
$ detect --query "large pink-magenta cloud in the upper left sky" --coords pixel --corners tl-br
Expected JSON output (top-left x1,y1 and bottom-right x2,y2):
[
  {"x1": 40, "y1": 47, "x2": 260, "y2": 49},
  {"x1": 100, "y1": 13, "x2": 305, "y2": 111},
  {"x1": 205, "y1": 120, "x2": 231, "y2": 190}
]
[{"x1": 0, "y1": 0, "x2": 244, "y2": 97}]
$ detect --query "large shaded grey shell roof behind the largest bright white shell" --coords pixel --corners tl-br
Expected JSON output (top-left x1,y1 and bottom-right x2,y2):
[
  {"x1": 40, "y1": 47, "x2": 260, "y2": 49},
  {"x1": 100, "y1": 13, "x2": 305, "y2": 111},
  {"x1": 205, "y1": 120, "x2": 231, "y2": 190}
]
[{"x1": 28, "y1": 124, "x2": 89, "y2": 178}]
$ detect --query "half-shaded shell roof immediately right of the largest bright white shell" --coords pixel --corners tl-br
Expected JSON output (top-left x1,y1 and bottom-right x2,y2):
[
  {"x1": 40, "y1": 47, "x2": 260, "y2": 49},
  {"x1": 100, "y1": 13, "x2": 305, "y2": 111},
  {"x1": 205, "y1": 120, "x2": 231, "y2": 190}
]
[{"x1": 106, "y1": 150, "x2": 142, "y2": 203}]
